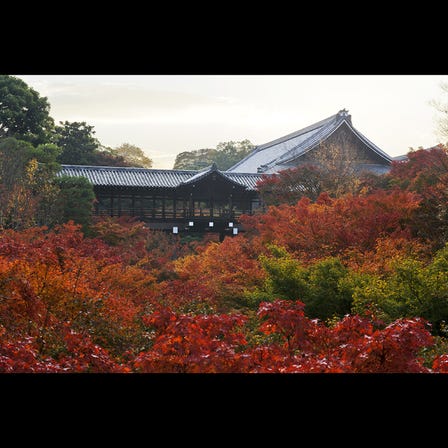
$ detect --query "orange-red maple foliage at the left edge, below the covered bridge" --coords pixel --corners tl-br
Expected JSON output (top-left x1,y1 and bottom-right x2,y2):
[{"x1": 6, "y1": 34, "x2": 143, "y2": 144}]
[{"x1": 0, "y1": 223, "x2": 155, "y2": 360}]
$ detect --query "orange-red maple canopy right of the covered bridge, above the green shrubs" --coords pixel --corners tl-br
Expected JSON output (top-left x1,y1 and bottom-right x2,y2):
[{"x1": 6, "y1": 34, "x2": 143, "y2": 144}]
[{"x1": 241, "y1": 190, "x2": 419, "y2": 260}]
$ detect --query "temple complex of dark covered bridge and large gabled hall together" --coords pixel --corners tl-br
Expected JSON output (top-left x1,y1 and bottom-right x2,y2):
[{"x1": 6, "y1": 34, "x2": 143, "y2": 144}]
[{"x1": 59, "y1": 109, "x2": 393, "y2": 239}]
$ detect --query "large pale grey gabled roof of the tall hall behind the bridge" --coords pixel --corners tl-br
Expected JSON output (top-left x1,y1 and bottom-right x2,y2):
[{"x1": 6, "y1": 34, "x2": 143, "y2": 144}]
[{"x1": 228, "y1": 109, "x2": 392, "y2": 173}]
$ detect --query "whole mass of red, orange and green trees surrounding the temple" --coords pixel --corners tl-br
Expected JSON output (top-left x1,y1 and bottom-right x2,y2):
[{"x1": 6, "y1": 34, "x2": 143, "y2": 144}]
[{"x1": 0, "y1": 78, "x2": 448, "y2": 373}]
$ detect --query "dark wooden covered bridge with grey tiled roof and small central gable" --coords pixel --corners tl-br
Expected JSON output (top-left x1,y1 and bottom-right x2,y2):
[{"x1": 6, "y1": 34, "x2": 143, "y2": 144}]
[{"x1": 58, "y1": 164, "x2": 262, "y2": 238}]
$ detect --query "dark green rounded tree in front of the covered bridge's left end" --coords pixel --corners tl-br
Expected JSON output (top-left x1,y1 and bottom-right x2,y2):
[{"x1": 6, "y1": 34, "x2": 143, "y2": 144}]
[{"x1": 57, "y1": 176, "x2": 95, "y2": 233}]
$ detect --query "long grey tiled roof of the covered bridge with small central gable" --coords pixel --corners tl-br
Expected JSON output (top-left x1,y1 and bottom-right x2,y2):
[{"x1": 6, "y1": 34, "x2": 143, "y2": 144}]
[{"x1": 57, "y1": 164, "x2": 262, "y2": 190}]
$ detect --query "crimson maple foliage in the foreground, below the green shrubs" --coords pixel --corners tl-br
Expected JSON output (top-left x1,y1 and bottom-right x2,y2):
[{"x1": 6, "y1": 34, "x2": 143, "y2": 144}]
[{"x1": 134, "y1": 300, "x2": 438, "y2": 373}]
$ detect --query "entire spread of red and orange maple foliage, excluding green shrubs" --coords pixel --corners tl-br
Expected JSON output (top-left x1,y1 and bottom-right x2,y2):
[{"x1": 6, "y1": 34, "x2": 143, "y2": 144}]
[{"x1": 0, "y1": 190, "x2": 448, "y2": 373}]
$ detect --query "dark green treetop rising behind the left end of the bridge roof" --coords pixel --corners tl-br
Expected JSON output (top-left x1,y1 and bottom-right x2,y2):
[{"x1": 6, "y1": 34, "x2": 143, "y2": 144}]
[{"x1": 53, "y1": 121, "x2": 99, "y2": 165}]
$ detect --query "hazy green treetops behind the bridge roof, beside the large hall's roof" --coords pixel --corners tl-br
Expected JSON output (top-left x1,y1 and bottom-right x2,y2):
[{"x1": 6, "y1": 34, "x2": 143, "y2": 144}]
[{"x1": 173, "y1": 140, "x2": 254, "y2": 171}]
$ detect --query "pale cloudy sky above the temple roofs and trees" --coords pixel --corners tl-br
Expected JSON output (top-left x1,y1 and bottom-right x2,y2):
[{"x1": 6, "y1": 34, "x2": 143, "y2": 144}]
[{"x1": 15, "y1": 74, "x2": 448, "y2": 169}]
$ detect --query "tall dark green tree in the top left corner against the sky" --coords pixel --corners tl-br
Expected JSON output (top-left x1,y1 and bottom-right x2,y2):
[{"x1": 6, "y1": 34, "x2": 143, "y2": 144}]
[{"x1": 0, "y1": 75, "x2": 54, "y2": 145}]
